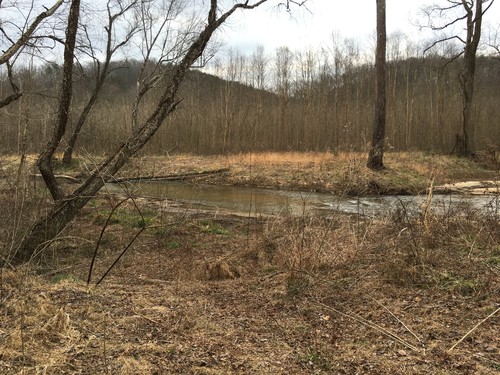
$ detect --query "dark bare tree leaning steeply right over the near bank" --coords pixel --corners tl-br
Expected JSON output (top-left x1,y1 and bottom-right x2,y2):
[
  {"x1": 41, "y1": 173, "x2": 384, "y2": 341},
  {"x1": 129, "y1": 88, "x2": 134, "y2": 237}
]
[{"x1": 14, "y1": 0, "x2": 286, "y2": 262}]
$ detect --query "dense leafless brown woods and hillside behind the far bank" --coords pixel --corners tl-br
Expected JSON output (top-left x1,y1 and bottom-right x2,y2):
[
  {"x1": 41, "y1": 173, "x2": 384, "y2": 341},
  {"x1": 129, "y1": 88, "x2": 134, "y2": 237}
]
[{"x1": 0, "y1": 49, "x2": 500, "y2": 154}]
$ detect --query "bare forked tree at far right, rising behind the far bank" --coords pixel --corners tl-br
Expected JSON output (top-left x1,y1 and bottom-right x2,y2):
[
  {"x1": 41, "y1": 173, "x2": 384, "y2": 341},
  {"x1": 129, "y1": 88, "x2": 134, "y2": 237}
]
[{"x1": 426, "y1": 0, "x2": 494, "y2": 156}]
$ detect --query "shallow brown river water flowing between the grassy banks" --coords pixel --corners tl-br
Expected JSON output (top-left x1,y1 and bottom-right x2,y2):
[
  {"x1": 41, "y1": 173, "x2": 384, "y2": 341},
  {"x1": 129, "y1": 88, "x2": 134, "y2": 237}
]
[{"x1": 106, "y1": 181, "x2": 500, "y2": 217}]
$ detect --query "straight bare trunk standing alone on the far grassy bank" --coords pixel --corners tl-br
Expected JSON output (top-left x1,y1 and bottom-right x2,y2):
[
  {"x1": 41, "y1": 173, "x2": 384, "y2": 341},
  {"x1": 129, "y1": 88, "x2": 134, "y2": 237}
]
[{"x1": 367, "y1": 0, "x2": 387, "y2": 170}]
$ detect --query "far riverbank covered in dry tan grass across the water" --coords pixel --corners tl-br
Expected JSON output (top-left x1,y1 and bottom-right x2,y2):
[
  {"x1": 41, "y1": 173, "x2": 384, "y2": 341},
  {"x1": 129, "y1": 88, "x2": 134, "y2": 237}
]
[{"x1": 88, "y1": 152, "x2": 500, "y2": 196}]
